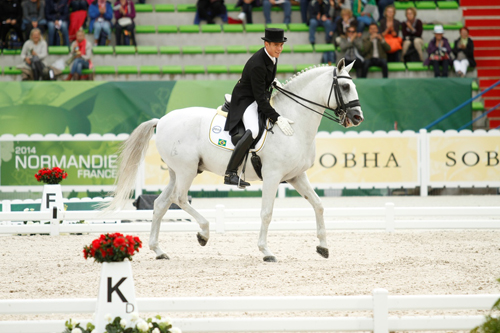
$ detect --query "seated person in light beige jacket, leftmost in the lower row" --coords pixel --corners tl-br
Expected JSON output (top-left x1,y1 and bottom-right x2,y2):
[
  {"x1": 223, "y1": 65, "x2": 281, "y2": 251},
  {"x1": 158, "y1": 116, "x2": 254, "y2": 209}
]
[{"x1": 21, "y1": 28, "x2": 48, "y2": 81}]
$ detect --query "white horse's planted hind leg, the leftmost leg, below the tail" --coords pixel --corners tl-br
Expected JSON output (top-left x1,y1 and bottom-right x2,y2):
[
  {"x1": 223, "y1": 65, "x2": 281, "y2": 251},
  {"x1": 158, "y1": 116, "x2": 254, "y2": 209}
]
[{"x1": 149, "y1": 169, "x2": 176, "y2": 259}]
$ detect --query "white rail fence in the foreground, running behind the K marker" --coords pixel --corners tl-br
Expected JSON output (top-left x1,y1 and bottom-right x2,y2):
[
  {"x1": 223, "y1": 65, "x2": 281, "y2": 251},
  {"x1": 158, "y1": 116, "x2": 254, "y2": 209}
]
[{"x1": 0, "y1": 289, "x2": 500, "y2": 333}]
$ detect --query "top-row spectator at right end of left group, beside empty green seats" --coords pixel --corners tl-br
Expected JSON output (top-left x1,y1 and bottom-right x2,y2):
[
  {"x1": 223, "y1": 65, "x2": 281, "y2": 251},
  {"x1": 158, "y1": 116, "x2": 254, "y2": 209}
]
[{"x1": 114, "y1": 0, "x2": 137, "y2": 46}]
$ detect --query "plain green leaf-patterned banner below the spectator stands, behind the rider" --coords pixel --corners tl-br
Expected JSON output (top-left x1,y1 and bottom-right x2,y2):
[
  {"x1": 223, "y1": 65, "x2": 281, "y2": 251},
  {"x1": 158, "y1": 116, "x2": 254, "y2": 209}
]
[{"x1": 0, "y1": 78, "x2": 472, "y2": 135}]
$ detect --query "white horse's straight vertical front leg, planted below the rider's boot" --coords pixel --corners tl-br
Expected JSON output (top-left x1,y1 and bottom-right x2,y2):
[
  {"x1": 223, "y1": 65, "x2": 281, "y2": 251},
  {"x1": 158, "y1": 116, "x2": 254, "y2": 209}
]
[{"x1": 258, "y1": 179, "x2": 280, "y2": 262}]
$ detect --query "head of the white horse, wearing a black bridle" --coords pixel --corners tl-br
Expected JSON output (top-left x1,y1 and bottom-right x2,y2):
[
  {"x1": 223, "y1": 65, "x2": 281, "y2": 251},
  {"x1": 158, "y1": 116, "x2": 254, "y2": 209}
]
[{"x1": 333, "y1": 58, "x2": 364, "y2": 128}]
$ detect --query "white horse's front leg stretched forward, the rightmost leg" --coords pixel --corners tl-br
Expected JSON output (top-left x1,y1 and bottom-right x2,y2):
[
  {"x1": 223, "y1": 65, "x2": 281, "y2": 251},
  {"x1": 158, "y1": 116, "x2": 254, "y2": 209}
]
[{"x1": 287, "y1": 172, "x2": 328, "y2": 258}]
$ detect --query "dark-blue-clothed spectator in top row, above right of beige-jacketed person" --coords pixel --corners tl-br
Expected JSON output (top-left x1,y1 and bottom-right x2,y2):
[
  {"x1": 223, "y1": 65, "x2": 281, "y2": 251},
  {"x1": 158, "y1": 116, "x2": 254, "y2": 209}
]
[{"x1": 45, "y1": 0, "x2": 69, "y2": 46}]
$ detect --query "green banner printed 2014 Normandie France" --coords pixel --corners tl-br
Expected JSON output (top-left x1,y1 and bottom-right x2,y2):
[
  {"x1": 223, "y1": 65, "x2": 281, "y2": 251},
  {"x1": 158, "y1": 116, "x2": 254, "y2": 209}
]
[{"x1": 0, "y1": 141, "x2": 121, "y2": 186}]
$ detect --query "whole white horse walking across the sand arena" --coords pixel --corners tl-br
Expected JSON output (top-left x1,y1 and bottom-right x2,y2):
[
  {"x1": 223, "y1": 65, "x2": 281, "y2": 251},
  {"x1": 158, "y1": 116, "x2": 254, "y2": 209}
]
[{"x1": 106, "y1": 59, "x2": 363, "y2": 262}]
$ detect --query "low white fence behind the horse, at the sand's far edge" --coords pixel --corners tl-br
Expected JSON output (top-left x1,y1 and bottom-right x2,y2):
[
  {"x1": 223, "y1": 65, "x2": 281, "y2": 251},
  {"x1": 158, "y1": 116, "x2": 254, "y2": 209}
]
[{"x1": 0, "y1": 201, "x2": 500, "y2": 236}]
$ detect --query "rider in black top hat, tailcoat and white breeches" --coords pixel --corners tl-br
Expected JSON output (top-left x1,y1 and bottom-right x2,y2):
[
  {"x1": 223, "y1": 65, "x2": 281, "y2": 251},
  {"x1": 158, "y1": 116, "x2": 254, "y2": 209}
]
[{"x1": 224, "y1": 28, "x2": 293, "y2": 187}]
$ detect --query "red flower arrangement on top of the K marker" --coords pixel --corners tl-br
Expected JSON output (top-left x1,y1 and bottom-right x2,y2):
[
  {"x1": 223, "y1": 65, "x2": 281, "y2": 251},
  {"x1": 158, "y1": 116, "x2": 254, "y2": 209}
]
[{"x1": 83, "y1": 232, "x2": 142, "y2": 263}]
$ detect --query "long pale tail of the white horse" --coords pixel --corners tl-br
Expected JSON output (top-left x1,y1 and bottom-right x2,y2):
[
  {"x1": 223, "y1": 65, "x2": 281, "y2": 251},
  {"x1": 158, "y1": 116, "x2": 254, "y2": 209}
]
[{"x1": 100, "y1": 118, "x2": 160, "y2": 212}]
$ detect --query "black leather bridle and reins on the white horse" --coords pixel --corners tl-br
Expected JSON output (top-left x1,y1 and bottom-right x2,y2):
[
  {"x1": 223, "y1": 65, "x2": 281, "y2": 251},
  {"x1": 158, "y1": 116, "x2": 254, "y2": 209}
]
[{"x1": 275, "y1": 67, "x2": 361, "y2": 126}]
